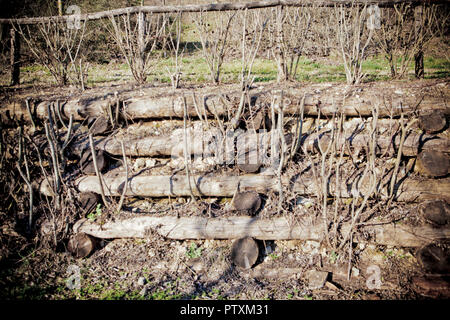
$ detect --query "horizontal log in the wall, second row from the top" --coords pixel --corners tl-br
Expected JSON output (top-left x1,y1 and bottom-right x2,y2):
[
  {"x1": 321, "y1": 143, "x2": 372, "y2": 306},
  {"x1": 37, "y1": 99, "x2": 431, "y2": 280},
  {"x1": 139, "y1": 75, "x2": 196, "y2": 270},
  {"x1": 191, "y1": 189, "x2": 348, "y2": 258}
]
[{"x1": 87, "y1": 129, "x2": 450, "y2": 157}]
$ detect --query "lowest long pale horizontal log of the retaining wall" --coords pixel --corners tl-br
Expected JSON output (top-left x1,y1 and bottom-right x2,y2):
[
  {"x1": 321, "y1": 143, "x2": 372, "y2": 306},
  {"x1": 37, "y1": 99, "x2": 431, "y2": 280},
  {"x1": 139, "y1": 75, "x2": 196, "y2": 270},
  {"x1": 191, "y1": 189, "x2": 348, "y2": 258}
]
[{"x1": 74, "y1": 216, "x2": 450, "y2": 247}]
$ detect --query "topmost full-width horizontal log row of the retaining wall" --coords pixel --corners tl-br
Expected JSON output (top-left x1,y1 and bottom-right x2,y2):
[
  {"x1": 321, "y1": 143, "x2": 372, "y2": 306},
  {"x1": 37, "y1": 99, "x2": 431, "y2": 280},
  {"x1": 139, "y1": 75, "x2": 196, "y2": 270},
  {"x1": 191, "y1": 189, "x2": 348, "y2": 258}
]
[{"x1": 5, "y1": 81, "x2": 450, "y2": 121}]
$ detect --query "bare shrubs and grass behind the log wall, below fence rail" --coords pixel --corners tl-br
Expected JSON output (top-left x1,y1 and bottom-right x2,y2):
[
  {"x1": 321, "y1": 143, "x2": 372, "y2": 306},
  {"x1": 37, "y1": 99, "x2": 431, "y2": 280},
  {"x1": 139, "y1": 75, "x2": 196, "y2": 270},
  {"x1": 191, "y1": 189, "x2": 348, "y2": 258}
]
[{"x1": 0, "y1": 0, "x2": 450, "y2": 89}]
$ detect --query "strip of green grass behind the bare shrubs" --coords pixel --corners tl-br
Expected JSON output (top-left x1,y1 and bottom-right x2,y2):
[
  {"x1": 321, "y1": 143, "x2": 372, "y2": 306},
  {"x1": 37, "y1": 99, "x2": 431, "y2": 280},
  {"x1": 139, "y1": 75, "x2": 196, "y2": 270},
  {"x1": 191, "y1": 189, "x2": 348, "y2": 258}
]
[{"x1": 0, "y1": 51, "x2": 450, "y2": 87}]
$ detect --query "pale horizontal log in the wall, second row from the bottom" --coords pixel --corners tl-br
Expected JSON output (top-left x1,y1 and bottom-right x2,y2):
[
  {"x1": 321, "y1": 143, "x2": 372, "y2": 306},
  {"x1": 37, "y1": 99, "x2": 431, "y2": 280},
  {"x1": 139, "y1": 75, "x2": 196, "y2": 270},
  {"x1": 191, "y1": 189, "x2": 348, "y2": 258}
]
[{"x1": 75, "y1": 173, "x2": 450, "y2": 202}]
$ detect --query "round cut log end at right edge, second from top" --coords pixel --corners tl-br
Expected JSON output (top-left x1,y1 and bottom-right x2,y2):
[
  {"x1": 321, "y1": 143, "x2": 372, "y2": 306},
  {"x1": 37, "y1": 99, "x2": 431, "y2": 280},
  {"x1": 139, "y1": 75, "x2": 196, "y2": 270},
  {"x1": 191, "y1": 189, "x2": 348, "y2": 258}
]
[{"x1": 415, "y1": 150, "x2": 450, "y2": 177}]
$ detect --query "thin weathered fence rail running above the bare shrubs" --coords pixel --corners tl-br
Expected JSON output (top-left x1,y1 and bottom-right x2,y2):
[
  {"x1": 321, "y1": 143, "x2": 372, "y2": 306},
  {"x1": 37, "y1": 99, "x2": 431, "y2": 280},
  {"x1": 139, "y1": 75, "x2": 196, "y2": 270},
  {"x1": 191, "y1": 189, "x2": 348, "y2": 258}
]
[{"x1": 0, "y1": 0, "x2": 440, "y2": 24}]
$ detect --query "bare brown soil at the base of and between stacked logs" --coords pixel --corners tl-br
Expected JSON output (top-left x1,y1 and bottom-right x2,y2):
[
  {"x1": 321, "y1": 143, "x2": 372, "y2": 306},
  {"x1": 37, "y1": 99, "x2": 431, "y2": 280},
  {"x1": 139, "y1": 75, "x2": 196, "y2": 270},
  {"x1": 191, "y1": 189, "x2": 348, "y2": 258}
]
[{"x1": 0, "y1": 77, "x2": 448, "y2": 300}]
